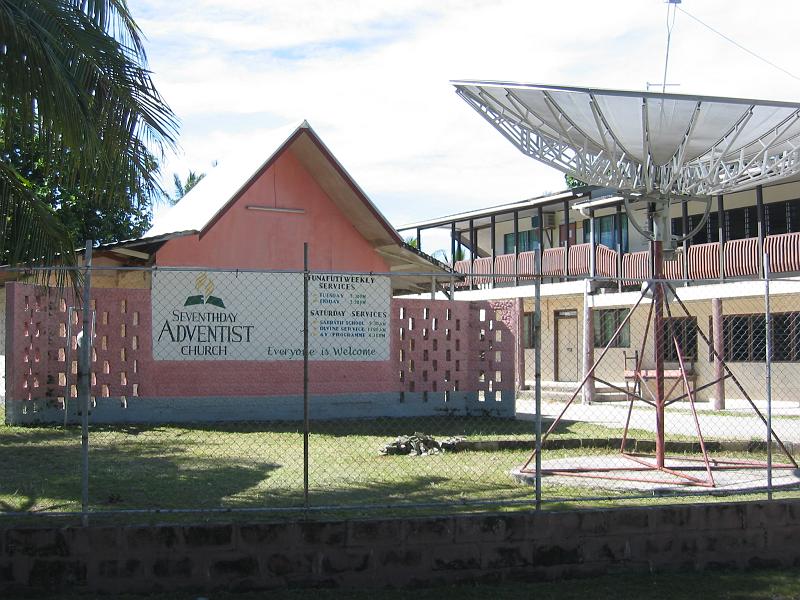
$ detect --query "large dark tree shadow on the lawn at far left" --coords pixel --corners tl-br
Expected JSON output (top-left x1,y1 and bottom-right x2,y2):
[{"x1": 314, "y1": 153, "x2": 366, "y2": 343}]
[{"x1": 0, "y1": 430, "x2": 282, "y2": 512}]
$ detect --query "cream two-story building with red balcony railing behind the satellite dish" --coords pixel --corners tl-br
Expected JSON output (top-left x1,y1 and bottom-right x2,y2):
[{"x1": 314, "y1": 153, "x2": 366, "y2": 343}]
[{"x1": 399, "y1": 181, "x2": 800, "y2": 400}]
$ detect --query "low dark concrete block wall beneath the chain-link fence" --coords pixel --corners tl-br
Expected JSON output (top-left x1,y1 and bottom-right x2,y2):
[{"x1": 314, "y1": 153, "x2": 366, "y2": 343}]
[{"x1": 0, "y1": 501, "x2": 800, "y2": 593}]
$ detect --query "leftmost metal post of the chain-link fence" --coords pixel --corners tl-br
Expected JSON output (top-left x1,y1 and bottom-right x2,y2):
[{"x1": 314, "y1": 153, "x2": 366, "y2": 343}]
[{"x1": 78, "y1": 240, "x2": 94, "y2": 527}]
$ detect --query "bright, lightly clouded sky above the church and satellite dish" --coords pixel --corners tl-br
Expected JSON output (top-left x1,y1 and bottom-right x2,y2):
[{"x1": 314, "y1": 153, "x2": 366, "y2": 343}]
[{"x1": 134, "y1": 0, "x2": 800, "y2": 251}]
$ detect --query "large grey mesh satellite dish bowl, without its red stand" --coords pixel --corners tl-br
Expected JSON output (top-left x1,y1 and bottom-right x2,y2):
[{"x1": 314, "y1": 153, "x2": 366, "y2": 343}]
[{"x1": 453, "y1": 81, "x2": 800, "y2": 251}]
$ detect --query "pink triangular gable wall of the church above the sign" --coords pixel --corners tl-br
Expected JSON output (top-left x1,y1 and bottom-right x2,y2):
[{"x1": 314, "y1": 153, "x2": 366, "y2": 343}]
[{"x1": 156, "y1": 151, "x2": 389, "y2": 272}]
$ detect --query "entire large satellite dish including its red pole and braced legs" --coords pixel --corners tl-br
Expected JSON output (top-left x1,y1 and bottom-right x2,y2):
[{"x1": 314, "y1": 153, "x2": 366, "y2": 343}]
[{"x1": 454, "y1": 82, "x2": 800, "y2": 487}]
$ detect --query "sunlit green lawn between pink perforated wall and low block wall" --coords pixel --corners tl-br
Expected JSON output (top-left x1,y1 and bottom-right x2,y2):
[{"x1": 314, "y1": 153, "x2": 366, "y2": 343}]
[{"x1": 0, "y1": 406, "x2": 796, "y2": 513}]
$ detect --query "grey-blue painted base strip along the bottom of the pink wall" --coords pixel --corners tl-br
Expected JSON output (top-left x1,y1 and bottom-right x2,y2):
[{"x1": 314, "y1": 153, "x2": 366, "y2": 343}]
[{"x1": 6, "y1": 392, "x2": 514, "y2": 425}]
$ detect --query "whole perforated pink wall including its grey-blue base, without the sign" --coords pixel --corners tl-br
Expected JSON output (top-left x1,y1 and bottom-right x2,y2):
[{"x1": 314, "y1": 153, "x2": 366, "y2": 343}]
[{"x1": 5, "y1": 283, "x2": 522, "y2": 424}]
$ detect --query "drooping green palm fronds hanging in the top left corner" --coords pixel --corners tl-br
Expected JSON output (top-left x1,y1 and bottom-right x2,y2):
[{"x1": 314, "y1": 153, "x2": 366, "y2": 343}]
[{"x1": 0, "y1": 0, "x2": 177, "y2": 272}]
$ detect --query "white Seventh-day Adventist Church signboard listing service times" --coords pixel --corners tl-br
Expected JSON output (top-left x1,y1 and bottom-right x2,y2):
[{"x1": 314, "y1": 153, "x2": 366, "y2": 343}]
[{"x1": 152, "y1": 271, "x2": 391, "y2": 361}]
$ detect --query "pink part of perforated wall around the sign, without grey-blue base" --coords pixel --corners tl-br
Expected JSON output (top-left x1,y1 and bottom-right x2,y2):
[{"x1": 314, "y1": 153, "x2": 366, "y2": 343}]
[{"x1": 6, "y1": 283, "x2": 521, "y2": 402}]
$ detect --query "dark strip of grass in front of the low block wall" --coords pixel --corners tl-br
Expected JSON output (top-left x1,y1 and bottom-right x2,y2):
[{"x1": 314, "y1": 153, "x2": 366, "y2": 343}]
[{"x1": 8, "y1": 570, "x2": 800, "y2": 600}]
